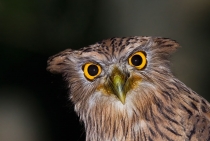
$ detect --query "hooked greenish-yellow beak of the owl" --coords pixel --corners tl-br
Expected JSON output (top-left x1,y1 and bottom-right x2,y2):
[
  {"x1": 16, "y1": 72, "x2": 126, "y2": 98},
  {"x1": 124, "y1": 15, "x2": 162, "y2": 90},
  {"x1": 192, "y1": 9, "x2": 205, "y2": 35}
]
[{"x1": 110, "y1": 68, "x2": 126, "y2": 104}]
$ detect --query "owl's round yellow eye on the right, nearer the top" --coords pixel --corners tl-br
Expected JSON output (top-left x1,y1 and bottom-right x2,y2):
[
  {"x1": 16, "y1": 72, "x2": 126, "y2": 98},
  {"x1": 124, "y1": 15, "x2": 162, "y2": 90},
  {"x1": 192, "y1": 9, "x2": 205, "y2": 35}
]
[{"x1": 128, "y1": 52, "x2": 147, "y2": 69}]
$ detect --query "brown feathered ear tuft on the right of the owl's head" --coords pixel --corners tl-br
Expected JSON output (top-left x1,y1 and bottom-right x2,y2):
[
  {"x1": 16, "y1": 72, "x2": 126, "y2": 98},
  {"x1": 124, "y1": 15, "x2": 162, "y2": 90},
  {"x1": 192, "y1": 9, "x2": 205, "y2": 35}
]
[{"x1": 153, "y1": 38, "x2": 180, "y2": 54}]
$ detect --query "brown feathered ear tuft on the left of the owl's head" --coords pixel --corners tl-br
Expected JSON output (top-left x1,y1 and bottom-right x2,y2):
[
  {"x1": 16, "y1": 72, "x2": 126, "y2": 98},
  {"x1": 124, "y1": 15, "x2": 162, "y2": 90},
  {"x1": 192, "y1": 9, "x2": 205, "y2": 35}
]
[{"x1": 47, "y1": 49, "x2": 73, "y2": 74}]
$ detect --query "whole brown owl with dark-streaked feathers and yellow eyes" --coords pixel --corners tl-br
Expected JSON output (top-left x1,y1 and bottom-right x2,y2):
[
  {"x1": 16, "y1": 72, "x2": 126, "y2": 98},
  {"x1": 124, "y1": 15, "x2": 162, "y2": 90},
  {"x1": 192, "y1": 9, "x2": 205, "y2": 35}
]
[{"x1": 47, "y1": 37, "x2": 210, "y2": 141}]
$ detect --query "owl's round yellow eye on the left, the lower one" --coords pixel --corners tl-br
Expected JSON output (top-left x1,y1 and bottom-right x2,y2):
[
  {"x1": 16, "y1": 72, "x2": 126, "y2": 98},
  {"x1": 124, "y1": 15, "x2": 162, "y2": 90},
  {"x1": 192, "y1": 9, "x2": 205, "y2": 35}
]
[{"x1": 83, "y1": 63, "x2": 101, "y2": 80}]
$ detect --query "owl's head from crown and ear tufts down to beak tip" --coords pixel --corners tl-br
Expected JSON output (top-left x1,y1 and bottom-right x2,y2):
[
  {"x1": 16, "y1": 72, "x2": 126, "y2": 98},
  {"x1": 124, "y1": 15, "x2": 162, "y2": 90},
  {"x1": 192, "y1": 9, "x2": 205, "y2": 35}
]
[{"x1": 48, "y1": 37, "x2": 178, "y2": 110}]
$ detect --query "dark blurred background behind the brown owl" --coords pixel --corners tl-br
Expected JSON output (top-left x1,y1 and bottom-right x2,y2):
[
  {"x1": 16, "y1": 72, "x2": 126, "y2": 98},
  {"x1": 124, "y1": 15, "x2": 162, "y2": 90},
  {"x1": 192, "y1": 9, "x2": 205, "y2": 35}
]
[{"x1": 0, "y1": 0, "x2": 210, "y2": 141}]
